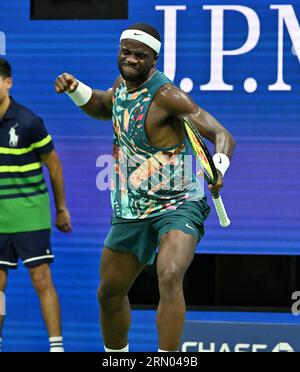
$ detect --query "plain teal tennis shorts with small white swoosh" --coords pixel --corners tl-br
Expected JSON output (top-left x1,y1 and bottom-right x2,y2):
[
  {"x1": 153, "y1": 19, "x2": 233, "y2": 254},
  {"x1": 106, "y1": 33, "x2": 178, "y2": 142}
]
[{"x1": 104, "y1": 198, "x2": 210, "y2": 265}]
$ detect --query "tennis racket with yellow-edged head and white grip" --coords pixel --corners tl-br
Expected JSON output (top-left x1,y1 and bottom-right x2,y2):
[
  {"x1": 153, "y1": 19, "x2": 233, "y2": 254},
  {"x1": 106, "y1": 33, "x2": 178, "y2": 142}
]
[{"x1": 183, "y1": 116, "x2": 230, "y2": 227}]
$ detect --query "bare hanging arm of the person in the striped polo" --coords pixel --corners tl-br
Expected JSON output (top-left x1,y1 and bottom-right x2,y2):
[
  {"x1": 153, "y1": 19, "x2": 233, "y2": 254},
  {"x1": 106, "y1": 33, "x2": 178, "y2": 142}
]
[{"x1": 40, "y1": 150, "x2": 72, "y2": 233}]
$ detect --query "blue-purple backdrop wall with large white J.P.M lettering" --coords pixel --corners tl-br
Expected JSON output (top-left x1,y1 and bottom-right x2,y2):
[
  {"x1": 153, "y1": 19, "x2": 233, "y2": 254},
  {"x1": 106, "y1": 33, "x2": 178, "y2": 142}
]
[{"x1": 0, "y1": 0, "x2": 300, "y2": 254}]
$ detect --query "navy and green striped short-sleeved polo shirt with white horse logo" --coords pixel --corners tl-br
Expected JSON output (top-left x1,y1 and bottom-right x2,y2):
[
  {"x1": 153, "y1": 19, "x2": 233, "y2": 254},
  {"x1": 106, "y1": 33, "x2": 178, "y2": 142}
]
[{"x1": 0, "y1": 99, "x2": 53, "y2": 233}]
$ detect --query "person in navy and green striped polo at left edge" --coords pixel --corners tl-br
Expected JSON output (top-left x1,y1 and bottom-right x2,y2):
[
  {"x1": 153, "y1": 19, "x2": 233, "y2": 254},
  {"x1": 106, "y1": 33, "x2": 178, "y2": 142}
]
[{"x1": 0, "y1": 58, "x2": 71, "y2": 352}]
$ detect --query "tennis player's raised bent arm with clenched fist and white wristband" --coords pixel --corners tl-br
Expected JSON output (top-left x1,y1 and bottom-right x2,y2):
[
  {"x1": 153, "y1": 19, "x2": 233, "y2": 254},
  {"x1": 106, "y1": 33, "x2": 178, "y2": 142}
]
[{"x1": 54, "y1": 73, "x2": 118, "y2": 120}]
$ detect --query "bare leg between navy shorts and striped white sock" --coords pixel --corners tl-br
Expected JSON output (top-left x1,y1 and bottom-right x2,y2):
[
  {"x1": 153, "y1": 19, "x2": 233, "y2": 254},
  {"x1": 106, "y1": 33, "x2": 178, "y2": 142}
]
[{"x1": 29, "y1": 264, "x2": 61, "y2": 337}]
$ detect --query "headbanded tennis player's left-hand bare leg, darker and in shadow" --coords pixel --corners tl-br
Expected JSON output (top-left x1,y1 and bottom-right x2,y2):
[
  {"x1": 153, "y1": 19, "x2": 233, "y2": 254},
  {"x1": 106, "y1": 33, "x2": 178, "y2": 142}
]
[{"x1": 98, "y1": 248, "x2": 144, "y2": 350}]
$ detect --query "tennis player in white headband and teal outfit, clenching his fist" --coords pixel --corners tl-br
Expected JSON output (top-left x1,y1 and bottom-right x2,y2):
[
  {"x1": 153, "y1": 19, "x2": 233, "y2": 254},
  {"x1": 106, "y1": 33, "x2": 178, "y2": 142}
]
[{"x1": 55, "y1": 23, "x2": 235, "y2": 352}]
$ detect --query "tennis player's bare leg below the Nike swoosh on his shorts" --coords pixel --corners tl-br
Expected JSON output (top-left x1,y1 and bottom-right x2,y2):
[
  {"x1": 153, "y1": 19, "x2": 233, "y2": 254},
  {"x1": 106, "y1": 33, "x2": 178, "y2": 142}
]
[{"x1": 157, "y1": 230, "x2": 197, "y2": 351}]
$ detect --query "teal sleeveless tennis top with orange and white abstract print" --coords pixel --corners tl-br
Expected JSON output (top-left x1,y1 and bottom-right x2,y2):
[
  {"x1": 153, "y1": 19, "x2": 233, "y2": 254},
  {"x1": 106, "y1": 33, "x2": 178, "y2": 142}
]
[{"x1": 111, "y1": 71, "x2": 203, "y2": 219}]
